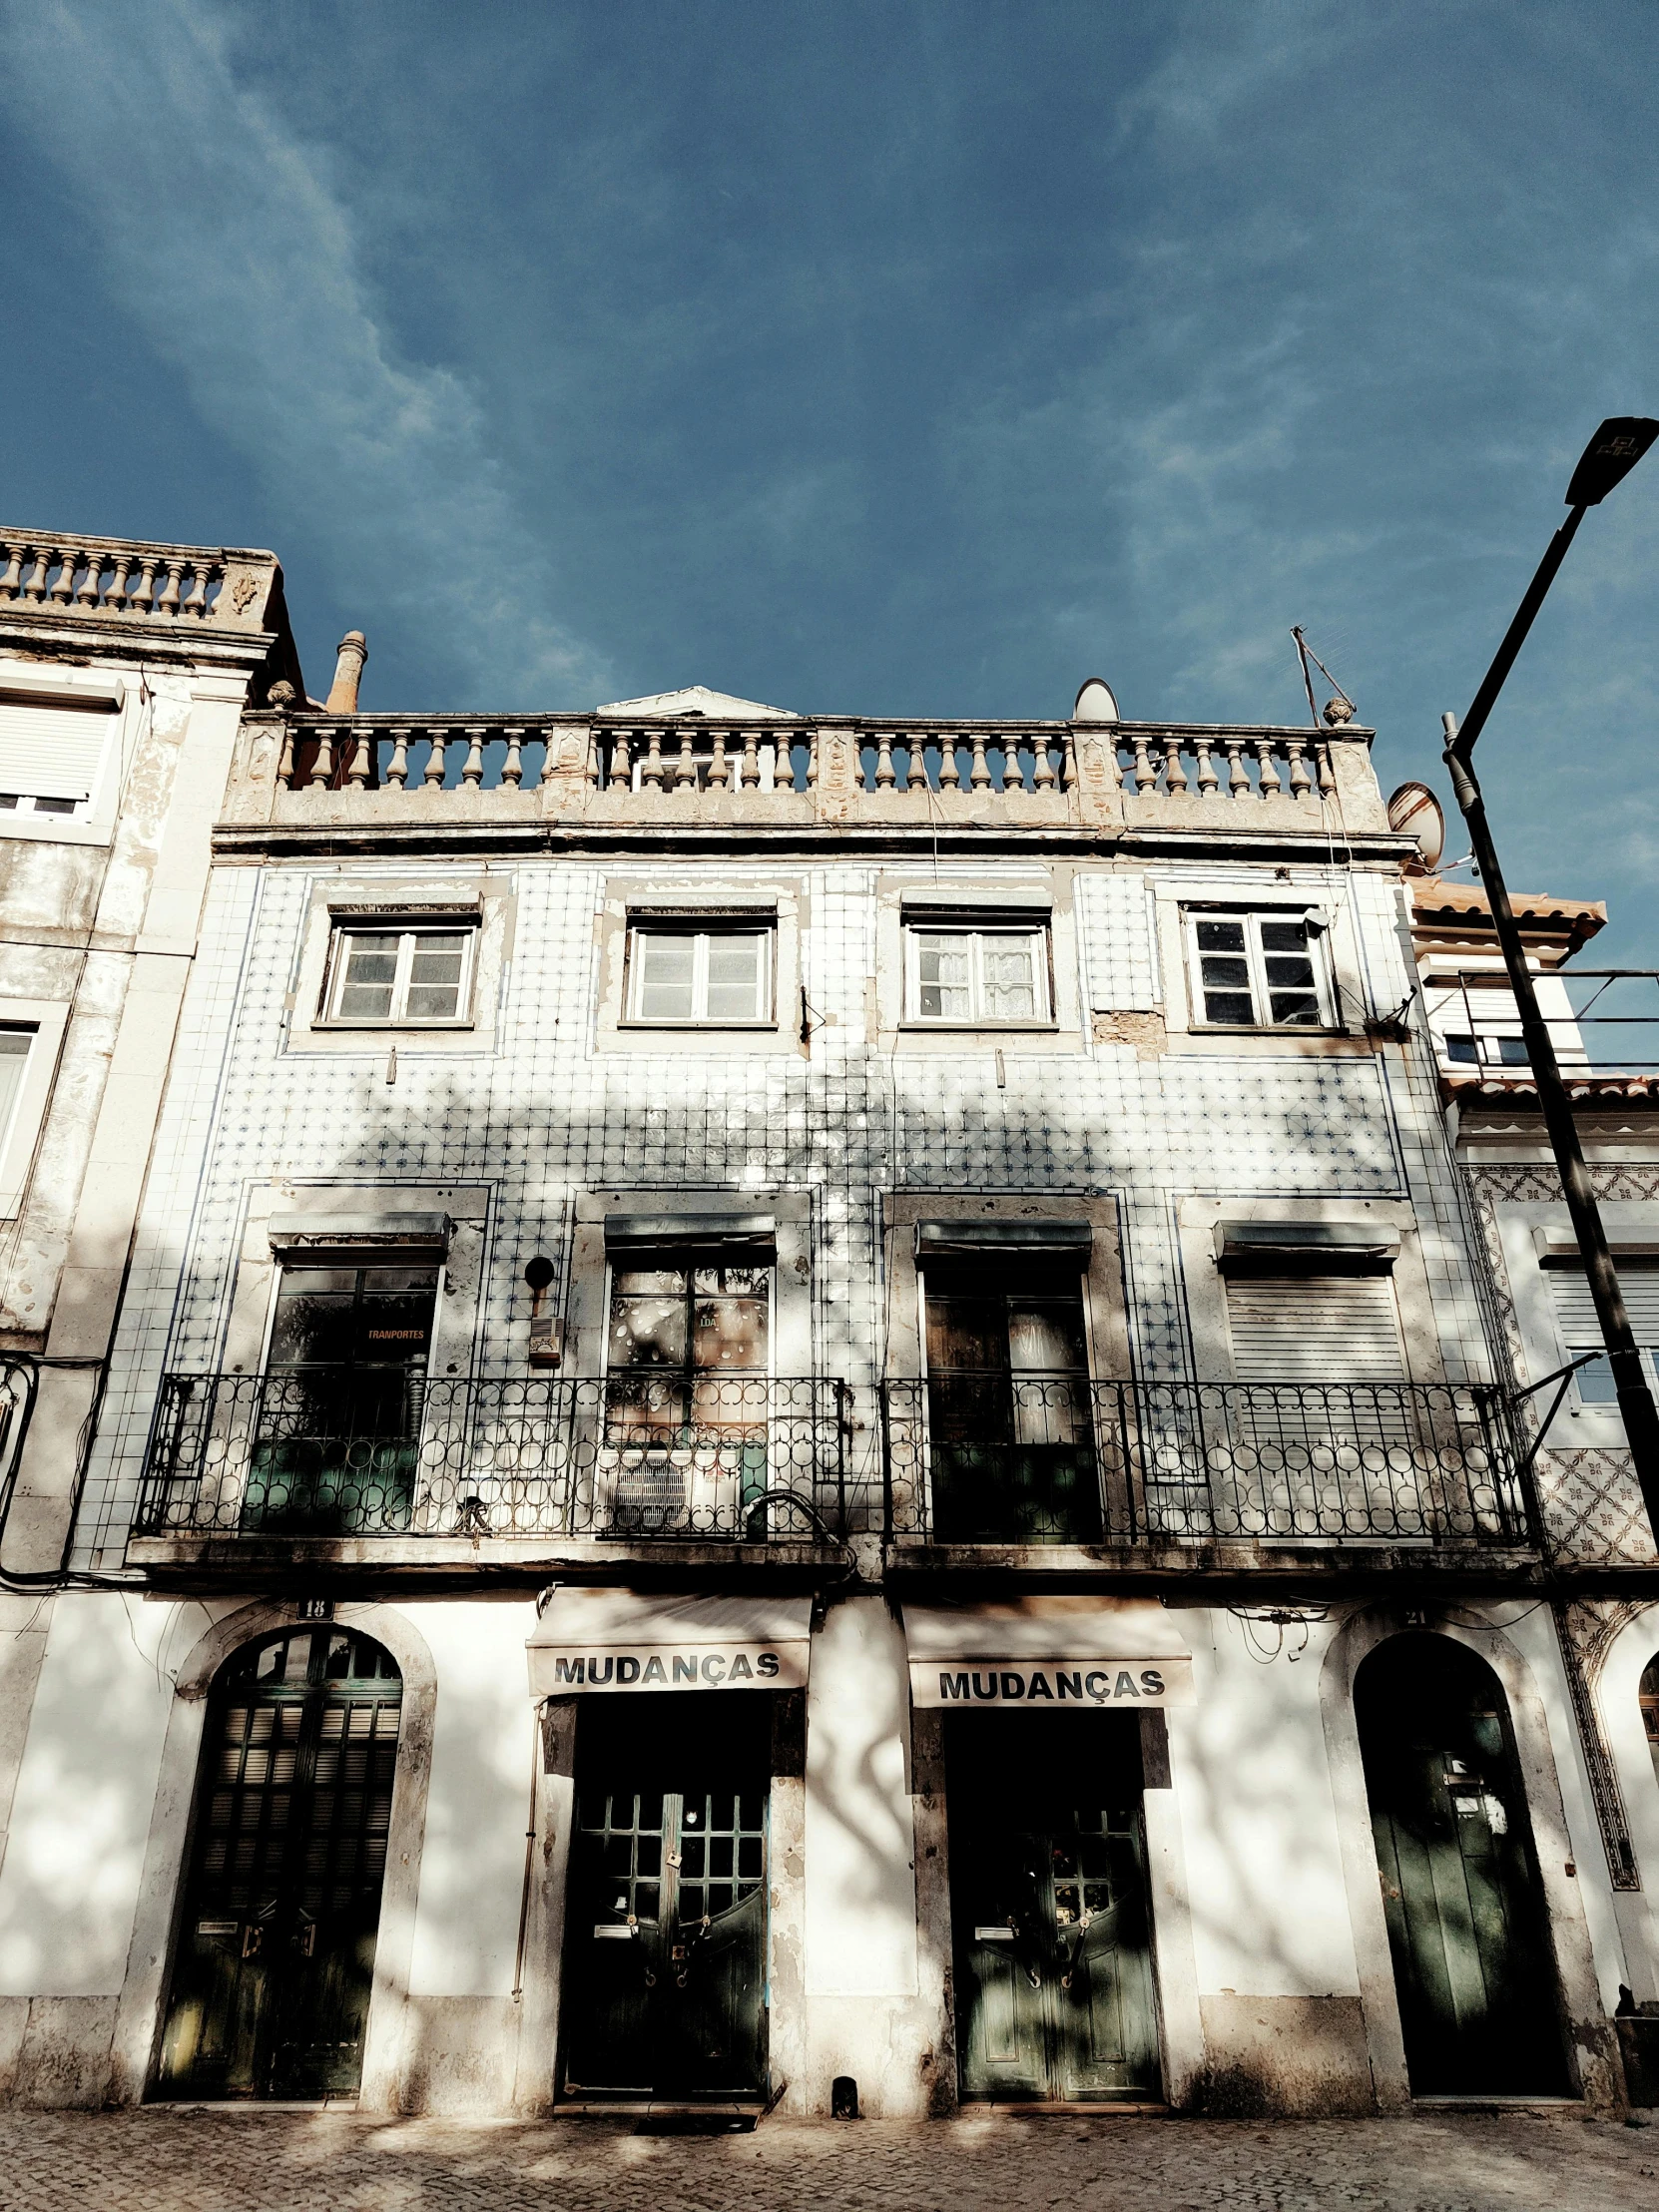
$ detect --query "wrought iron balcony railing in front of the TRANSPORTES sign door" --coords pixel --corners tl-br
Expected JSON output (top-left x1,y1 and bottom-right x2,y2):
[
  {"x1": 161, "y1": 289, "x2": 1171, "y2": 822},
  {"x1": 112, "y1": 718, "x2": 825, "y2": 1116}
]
[{"x1": 133, "y1": 1367, "x2": 847, "y2": 1542}]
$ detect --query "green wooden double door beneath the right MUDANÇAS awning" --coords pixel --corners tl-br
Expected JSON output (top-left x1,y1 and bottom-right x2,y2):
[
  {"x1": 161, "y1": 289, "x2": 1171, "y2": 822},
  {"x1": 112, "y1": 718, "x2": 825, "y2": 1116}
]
[{"x1": 949, "y1": 1714, "x2": 1161, "y2": 2101}]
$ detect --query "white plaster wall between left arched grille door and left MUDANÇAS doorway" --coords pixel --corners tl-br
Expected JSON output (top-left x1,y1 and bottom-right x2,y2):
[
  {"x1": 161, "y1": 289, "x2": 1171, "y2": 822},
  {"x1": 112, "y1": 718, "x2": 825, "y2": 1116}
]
[{"x1": 398, "y1": 1601, "x2": 535, "y2": 1997}]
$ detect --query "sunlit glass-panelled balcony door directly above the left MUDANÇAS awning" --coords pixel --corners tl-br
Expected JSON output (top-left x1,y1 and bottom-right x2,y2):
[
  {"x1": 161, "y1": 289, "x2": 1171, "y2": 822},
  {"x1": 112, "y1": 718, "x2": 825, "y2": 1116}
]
[{"x1": 600, "y1": 1246, "x2": 772, "y2": 1535}]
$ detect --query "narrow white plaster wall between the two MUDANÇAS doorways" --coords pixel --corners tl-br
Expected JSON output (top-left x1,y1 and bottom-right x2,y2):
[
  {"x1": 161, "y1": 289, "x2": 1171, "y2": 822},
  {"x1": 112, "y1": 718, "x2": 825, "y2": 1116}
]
[{"x1": 806, "y1": 1597, "x2": 915, "y2": 1997}]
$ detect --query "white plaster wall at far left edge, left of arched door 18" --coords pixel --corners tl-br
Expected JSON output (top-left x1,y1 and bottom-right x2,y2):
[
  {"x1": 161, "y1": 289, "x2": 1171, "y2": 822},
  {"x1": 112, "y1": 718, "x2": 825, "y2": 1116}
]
[{"x1": 0, "y1": 1593, "x2": 177, "y2": 1997}]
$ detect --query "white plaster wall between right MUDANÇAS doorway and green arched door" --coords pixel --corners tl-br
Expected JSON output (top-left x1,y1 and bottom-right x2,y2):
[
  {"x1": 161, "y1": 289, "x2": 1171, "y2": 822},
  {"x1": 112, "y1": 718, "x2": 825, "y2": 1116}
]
[{"x1": 1168, "y1": 1610, "x2": 1359, "y2": 1997}]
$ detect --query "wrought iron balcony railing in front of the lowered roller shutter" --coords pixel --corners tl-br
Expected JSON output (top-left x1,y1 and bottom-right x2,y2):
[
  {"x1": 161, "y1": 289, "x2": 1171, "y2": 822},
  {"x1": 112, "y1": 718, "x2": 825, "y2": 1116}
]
[{"x1": 882, "y1": 1374, "x2": 1535, "y2": 1544}]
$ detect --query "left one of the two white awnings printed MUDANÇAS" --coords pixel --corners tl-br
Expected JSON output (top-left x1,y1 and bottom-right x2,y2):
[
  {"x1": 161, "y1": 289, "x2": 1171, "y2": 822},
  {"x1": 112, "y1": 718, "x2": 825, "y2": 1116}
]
[{"x1": 526, "y1": 1590, "x2": 812, "y2": 1699}]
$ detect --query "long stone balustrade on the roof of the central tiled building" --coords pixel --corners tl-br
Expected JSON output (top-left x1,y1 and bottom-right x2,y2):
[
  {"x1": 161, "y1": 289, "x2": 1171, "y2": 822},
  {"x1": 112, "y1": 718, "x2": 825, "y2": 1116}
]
[{"x1": 230, "y1": 715, "x2": 1386, "y2": 833}]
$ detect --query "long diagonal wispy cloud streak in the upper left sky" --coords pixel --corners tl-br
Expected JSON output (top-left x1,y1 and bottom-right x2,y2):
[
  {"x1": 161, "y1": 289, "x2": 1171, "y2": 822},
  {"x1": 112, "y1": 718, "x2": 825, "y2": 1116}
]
[{"x1": 0, "y1": 0, "x2": 608, "y2": 708}]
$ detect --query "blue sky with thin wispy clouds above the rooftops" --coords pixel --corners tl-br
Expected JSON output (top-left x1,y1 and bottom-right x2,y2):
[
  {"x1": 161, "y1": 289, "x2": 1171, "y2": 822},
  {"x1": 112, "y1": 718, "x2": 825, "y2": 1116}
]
[{"x1": 0, "y1": 0, "x2": 1659, "y2": 964}]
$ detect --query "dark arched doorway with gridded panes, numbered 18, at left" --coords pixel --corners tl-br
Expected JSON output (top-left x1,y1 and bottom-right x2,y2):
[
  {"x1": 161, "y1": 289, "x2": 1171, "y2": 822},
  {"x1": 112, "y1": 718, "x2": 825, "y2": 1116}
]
[{"x1": 153, "y1": 1626, "x2": 402, "y2": 2097}]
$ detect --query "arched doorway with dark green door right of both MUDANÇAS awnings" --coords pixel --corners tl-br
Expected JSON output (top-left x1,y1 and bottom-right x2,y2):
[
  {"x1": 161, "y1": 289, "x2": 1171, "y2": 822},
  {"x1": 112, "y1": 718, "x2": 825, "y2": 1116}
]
[{"x1": 1354, "y1": 1635, "x2": 1570, "y2": 2097}]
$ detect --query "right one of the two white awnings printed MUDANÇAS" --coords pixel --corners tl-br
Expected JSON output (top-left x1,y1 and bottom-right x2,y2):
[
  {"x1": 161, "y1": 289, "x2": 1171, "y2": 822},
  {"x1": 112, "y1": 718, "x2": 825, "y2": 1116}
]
[{"x1": 904, "y1": 1597, "x2": 1195, "y2": 1712}]
